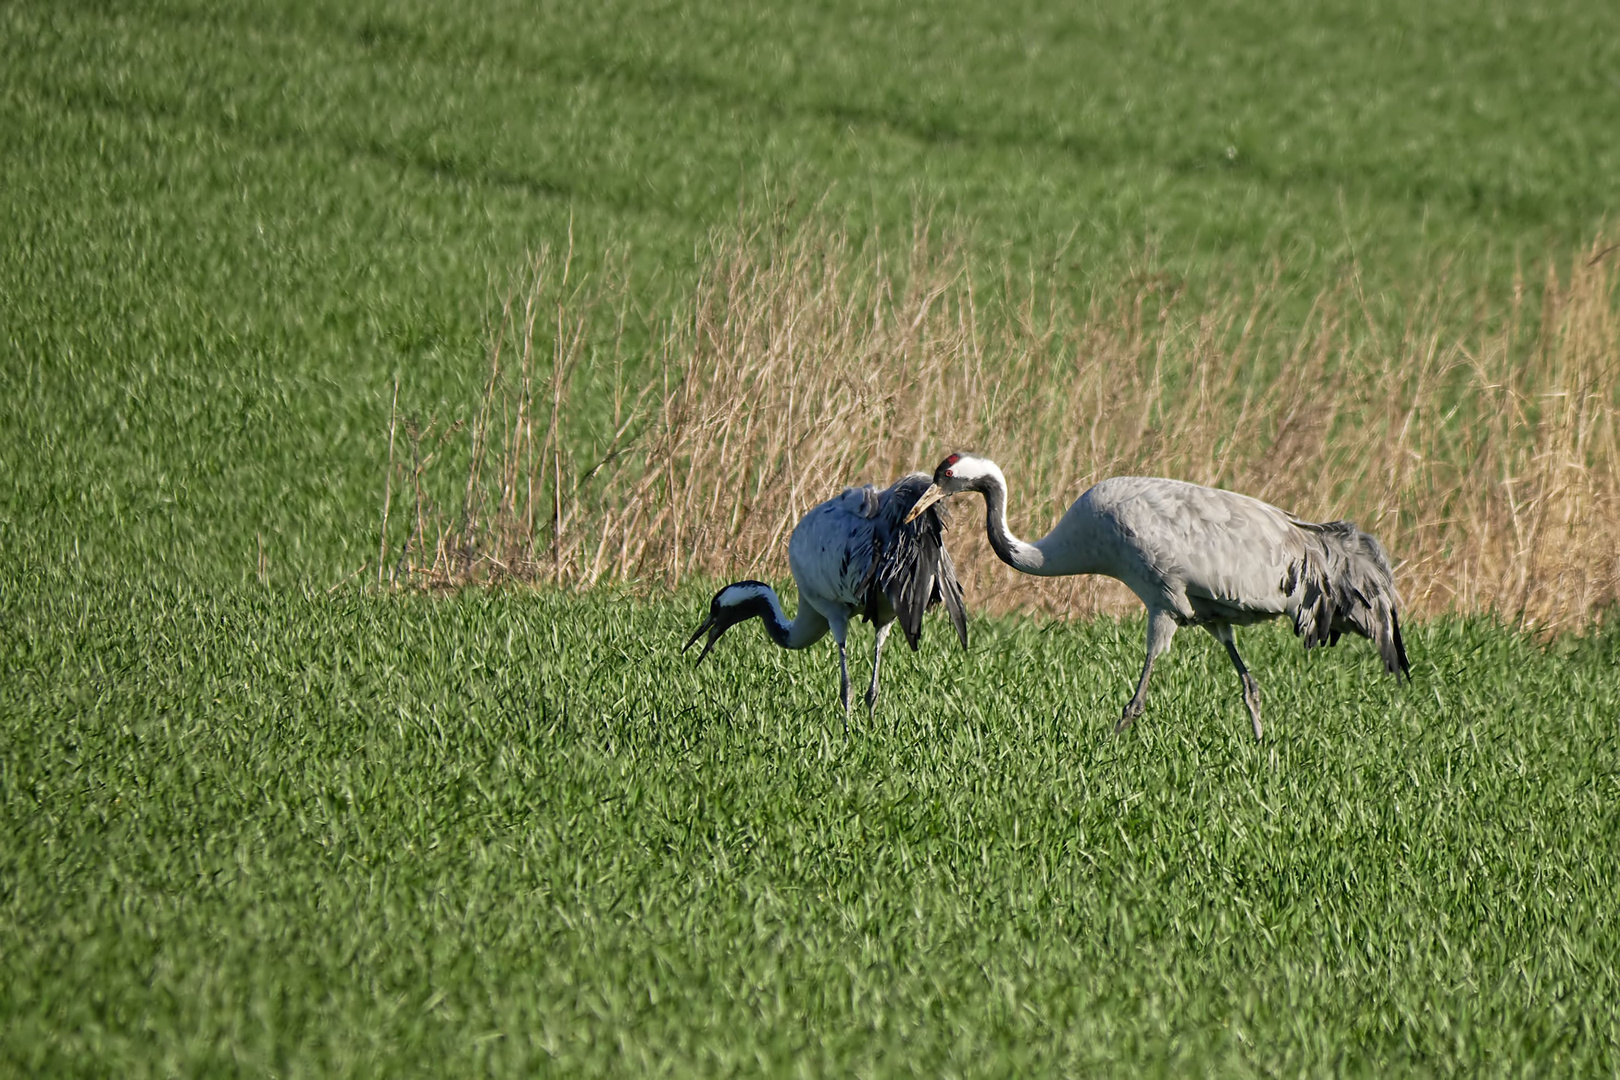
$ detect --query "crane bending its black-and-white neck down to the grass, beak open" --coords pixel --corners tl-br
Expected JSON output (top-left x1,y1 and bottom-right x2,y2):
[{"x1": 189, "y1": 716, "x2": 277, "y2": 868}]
[{"x1": 682, "y1": 473, "x2": 967, "y2": 732}]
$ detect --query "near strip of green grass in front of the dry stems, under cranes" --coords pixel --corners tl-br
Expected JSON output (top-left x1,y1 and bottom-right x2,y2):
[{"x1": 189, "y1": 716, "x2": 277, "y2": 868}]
[{"x1": 9, "y1": 588, "x2": 1620, "y2": 1077}]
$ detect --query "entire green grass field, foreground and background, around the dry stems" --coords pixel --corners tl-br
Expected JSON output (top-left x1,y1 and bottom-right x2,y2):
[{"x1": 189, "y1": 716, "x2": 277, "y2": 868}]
[{"x1": 0, "y1": 0, "x2": 1620, "y2": 1077}]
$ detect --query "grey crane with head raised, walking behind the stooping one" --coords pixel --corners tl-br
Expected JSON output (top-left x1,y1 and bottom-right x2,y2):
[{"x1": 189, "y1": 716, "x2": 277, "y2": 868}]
[{"x1": 910, "y1": 453, "x2": 1411, "y2": 740}]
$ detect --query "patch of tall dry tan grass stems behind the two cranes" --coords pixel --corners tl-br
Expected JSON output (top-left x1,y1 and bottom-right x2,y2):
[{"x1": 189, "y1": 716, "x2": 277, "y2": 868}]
[{"x1": 382, "y1": 216, "x2": 1620, "y2": 631}]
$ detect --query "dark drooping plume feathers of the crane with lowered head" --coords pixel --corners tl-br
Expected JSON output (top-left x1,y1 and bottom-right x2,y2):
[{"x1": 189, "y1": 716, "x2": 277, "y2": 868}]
[{"x1": 870, "y1": 473, "x2": 967, "y2": 649}]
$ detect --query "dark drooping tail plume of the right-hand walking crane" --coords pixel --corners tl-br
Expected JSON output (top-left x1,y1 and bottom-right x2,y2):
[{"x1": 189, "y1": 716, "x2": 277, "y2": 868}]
[{"x1": 1283, "y1": 521, "x2": 1411, "y2": 678}]
